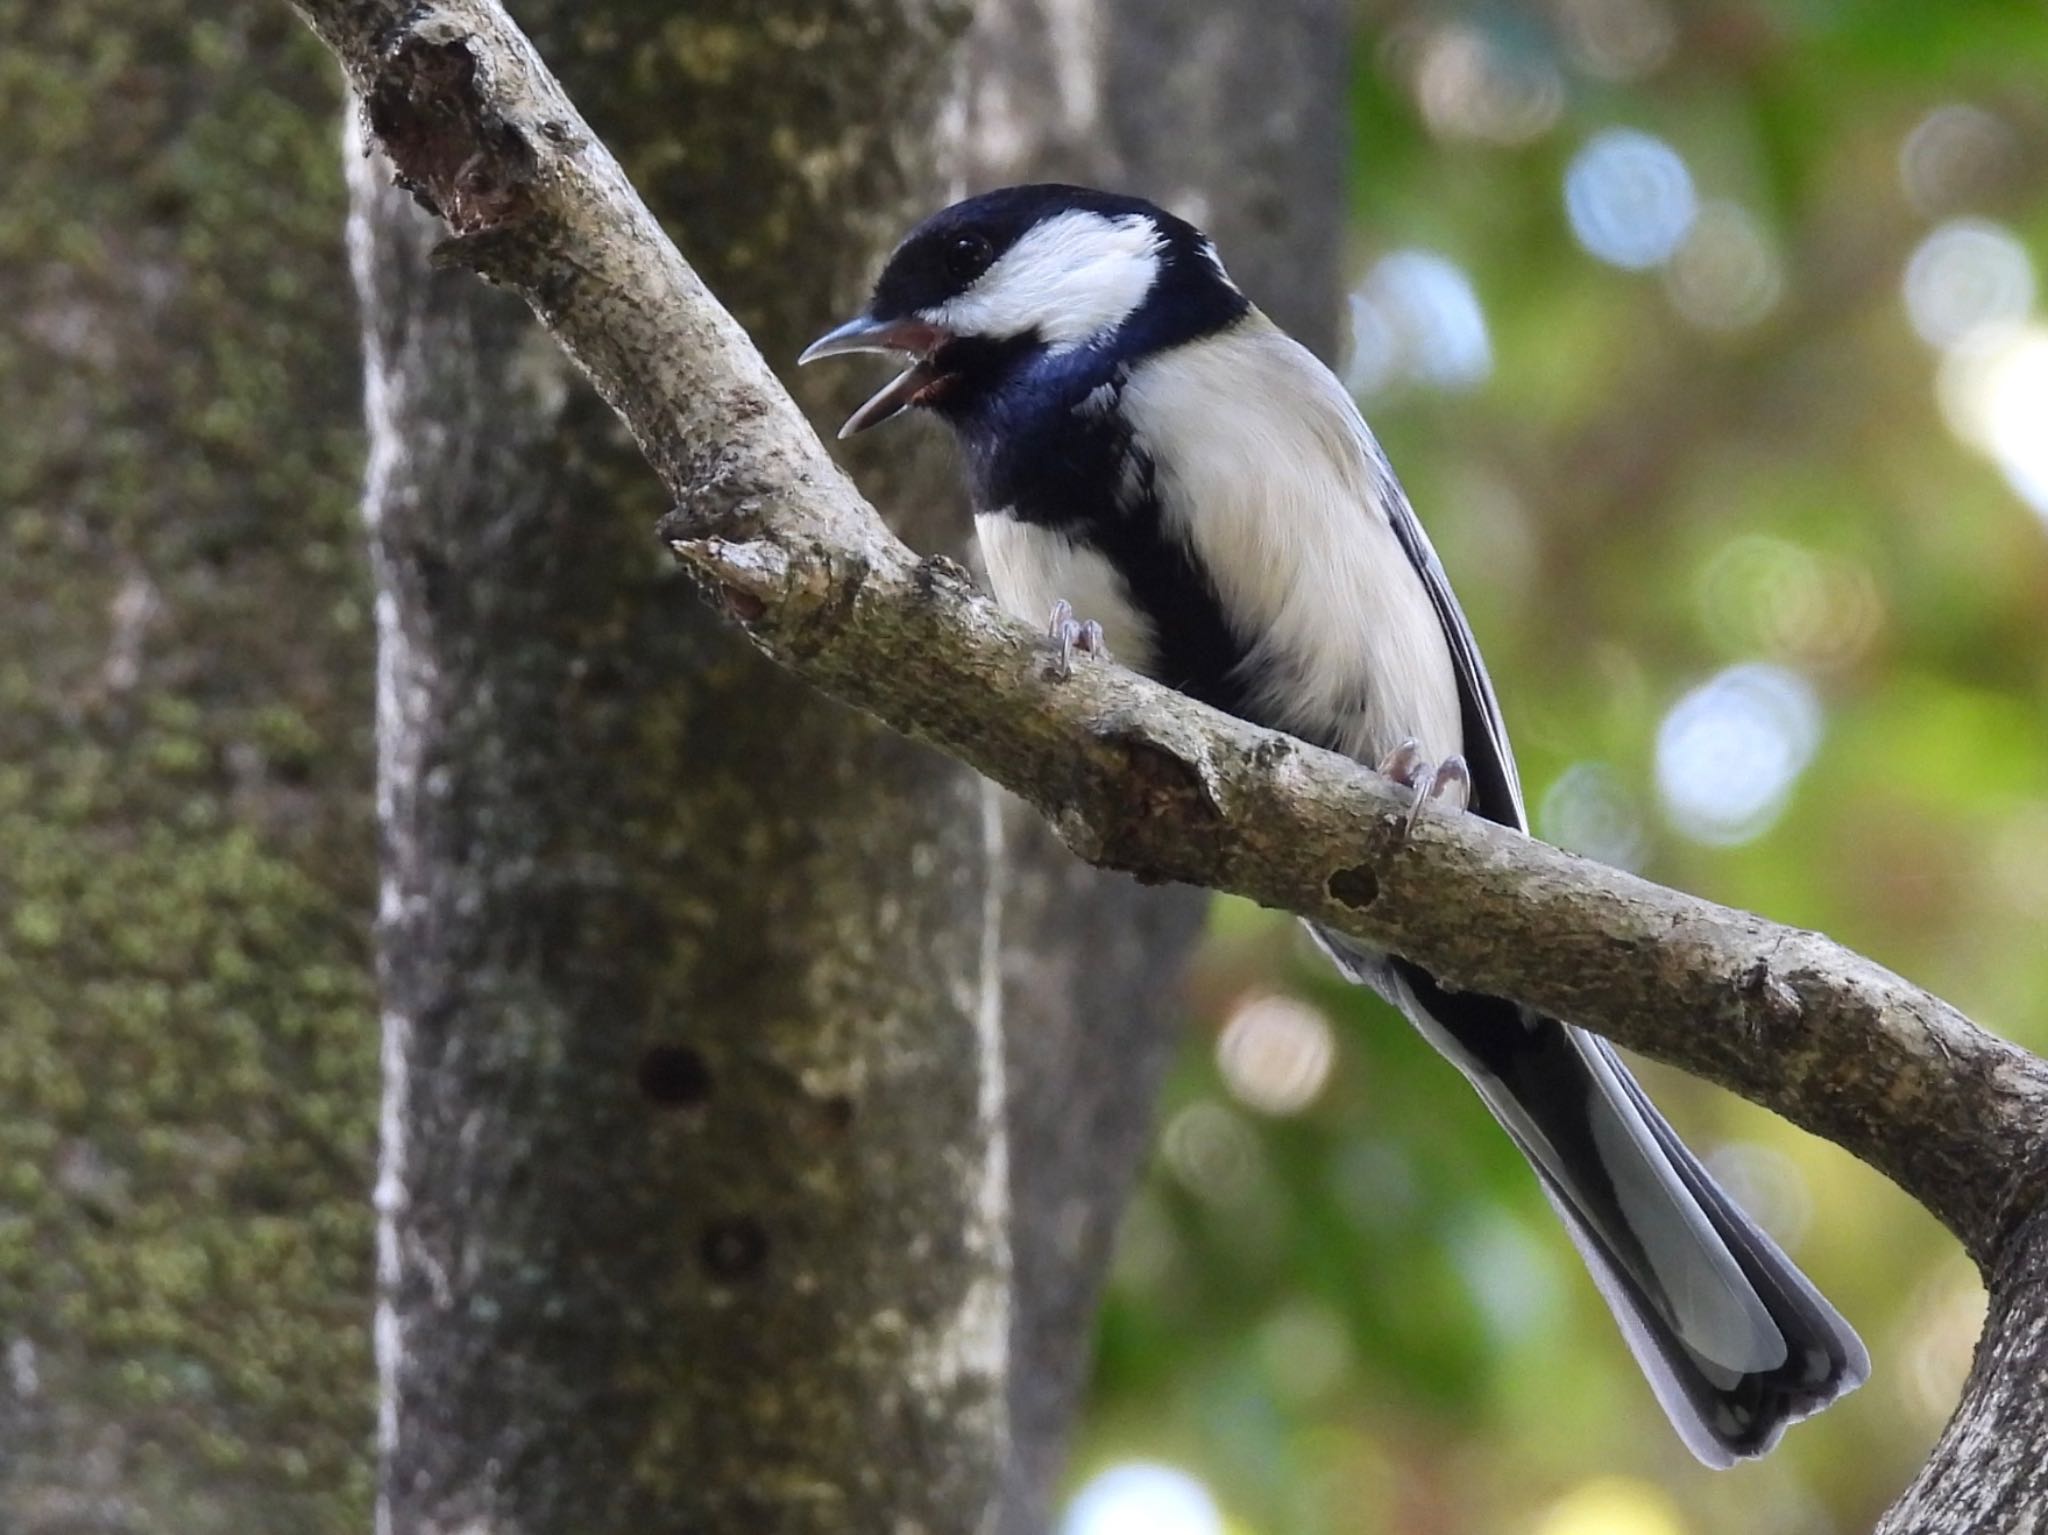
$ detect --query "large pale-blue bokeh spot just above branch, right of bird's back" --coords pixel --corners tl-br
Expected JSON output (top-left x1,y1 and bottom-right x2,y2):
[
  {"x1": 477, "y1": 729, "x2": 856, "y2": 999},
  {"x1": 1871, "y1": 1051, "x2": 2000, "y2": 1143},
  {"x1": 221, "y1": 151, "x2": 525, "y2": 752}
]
[{"x1": 1657, "y1": 661, "x2": 1821, "y2": 845}]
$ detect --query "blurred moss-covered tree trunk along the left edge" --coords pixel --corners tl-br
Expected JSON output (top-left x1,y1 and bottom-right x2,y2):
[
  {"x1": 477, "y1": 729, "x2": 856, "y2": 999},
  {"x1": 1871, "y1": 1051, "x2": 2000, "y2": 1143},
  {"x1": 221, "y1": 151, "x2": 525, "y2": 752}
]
[{"x1": 0, "y1": 0, "x2": 377, "y2": 1535}]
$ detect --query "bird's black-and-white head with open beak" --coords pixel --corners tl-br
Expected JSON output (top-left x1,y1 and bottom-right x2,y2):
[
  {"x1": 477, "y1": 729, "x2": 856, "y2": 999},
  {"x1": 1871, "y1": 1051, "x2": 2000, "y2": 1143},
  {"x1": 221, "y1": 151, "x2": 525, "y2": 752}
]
[{"x1": 799, "y1": 186, "x2": 1245, "y2": 438}]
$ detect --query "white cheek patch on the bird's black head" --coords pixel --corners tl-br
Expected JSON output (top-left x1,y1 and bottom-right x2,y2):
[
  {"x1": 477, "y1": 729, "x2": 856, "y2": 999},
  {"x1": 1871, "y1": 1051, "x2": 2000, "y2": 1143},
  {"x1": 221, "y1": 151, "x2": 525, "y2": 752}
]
[{"x1": 922, "y1": 211, "x2": 1161, "y2": 352}]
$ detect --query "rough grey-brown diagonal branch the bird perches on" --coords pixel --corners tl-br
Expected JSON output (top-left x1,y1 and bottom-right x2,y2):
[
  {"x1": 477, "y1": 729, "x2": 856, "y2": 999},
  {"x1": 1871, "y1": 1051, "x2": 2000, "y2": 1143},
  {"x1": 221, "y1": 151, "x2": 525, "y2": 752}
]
[{"x1": 295, "y1": 0, "x2": 2048, "y2": 1527}]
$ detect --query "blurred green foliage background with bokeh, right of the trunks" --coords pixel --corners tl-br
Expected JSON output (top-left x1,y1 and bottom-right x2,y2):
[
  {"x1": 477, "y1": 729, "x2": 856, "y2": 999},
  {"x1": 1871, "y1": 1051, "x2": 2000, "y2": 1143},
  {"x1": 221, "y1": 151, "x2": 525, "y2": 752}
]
[{"x1": 1065, "y1": 0, "x2": 2048, "y2": 1535}]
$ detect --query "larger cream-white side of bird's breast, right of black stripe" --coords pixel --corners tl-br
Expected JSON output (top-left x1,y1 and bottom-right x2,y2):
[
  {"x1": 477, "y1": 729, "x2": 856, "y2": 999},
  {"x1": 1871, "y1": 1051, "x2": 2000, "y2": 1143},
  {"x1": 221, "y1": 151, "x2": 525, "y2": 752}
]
[{"x1": 1124, "y1": 315, "x2": 1464, "y2": 761}]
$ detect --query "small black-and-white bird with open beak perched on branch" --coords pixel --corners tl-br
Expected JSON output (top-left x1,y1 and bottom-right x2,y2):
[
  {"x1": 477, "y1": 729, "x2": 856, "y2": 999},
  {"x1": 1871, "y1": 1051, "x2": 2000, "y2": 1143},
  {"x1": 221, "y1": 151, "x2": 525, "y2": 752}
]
[{"x1": 799, "y1": 186, "x2": 1870, "y2": 1467}]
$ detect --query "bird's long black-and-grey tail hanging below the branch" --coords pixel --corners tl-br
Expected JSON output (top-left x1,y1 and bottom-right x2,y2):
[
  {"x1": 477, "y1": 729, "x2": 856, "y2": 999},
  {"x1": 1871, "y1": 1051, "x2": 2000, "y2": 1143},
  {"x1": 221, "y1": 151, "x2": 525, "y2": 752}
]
[{"x1": 1317, "y1": 931, "x2": 1870, "y2": 1467}]
